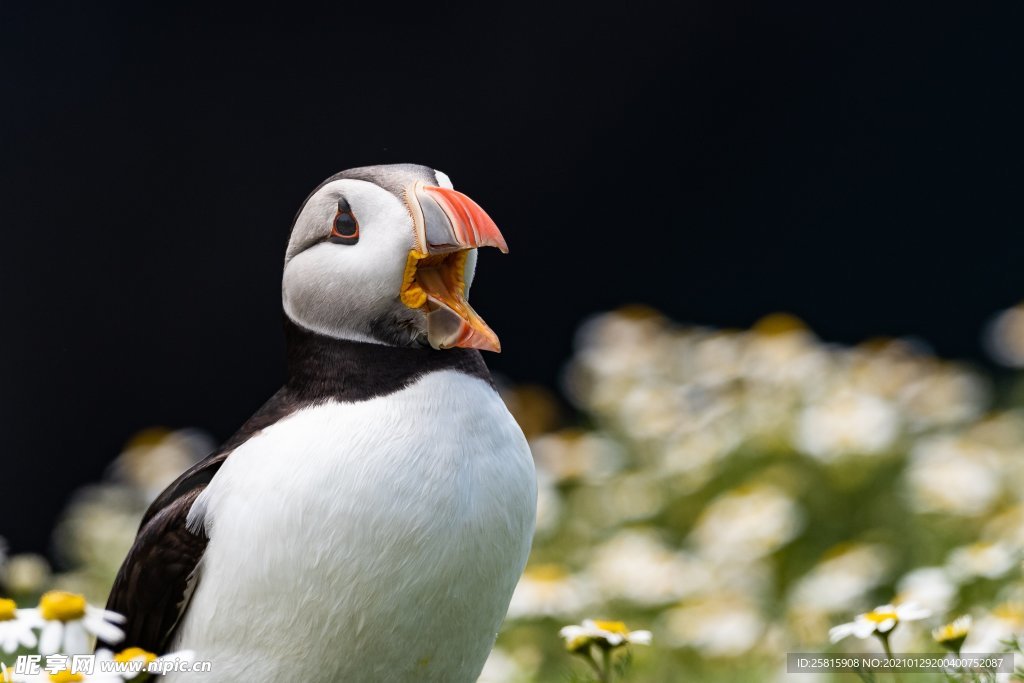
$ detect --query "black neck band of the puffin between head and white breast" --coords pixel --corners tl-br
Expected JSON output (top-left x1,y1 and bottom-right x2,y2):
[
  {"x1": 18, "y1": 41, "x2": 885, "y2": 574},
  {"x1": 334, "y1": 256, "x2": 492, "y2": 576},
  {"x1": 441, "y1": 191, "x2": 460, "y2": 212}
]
[{"x1": 285, "y1": 315, "x2": 494, "y2": 401}]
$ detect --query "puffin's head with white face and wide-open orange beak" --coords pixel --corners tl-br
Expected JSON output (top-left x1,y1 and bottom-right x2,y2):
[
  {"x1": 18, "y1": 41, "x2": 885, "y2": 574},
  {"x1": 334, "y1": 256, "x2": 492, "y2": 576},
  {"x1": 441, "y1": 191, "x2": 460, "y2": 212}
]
[{"x1": 282, "y1": 164, "x2": 508, "y2": 351}]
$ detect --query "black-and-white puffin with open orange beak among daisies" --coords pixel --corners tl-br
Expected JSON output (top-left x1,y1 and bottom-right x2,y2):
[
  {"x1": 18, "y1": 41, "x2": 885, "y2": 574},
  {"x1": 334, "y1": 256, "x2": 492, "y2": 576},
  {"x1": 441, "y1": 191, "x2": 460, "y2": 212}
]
[{"x1": 101, "y1": 164, "x2": 537, "y2": 683}]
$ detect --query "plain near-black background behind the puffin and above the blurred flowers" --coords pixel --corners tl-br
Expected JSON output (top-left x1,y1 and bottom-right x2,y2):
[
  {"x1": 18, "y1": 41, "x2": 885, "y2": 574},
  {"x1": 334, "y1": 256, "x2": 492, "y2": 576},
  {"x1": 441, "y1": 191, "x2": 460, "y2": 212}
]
[{"x1": 0, "y1": 1, "x2": 1024, "y2": 551}]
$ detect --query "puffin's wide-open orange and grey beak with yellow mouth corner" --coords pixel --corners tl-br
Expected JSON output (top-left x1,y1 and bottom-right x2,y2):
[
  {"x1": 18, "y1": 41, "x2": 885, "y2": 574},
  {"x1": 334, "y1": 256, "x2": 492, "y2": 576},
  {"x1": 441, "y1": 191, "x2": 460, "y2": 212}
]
[{"x1": 400, "y1": 181, "x2": 509, "y2": 352}]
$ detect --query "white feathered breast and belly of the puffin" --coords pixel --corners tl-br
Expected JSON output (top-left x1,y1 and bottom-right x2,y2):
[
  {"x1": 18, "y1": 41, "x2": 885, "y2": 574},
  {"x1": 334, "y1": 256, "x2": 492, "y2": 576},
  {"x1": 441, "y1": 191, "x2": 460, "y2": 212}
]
[{"x1": 170, "y1": 371, "x2": 536, "y2": 683}]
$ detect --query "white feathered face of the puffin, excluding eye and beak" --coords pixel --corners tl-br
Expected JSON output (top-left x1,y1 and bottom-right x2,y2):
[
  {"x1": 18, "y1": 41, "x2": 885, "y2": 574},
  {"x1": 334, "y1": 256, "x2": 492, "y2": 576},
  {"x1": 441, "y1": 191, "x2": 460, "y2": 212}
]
[{"x1": 282, "y1": 178, "x2": 476, "y2": 346}]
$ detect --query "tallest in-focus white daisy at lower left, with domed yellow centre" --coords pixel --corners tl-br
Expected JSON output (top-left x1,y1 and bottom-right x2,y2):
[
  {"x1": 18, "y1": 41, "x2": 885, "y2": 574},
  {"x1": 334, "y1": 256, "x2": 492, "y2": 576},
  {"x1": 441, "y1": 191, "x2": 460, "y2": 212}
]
[{"x1": 32, "y1": 591, "x2": 125, "y2": 655}]
